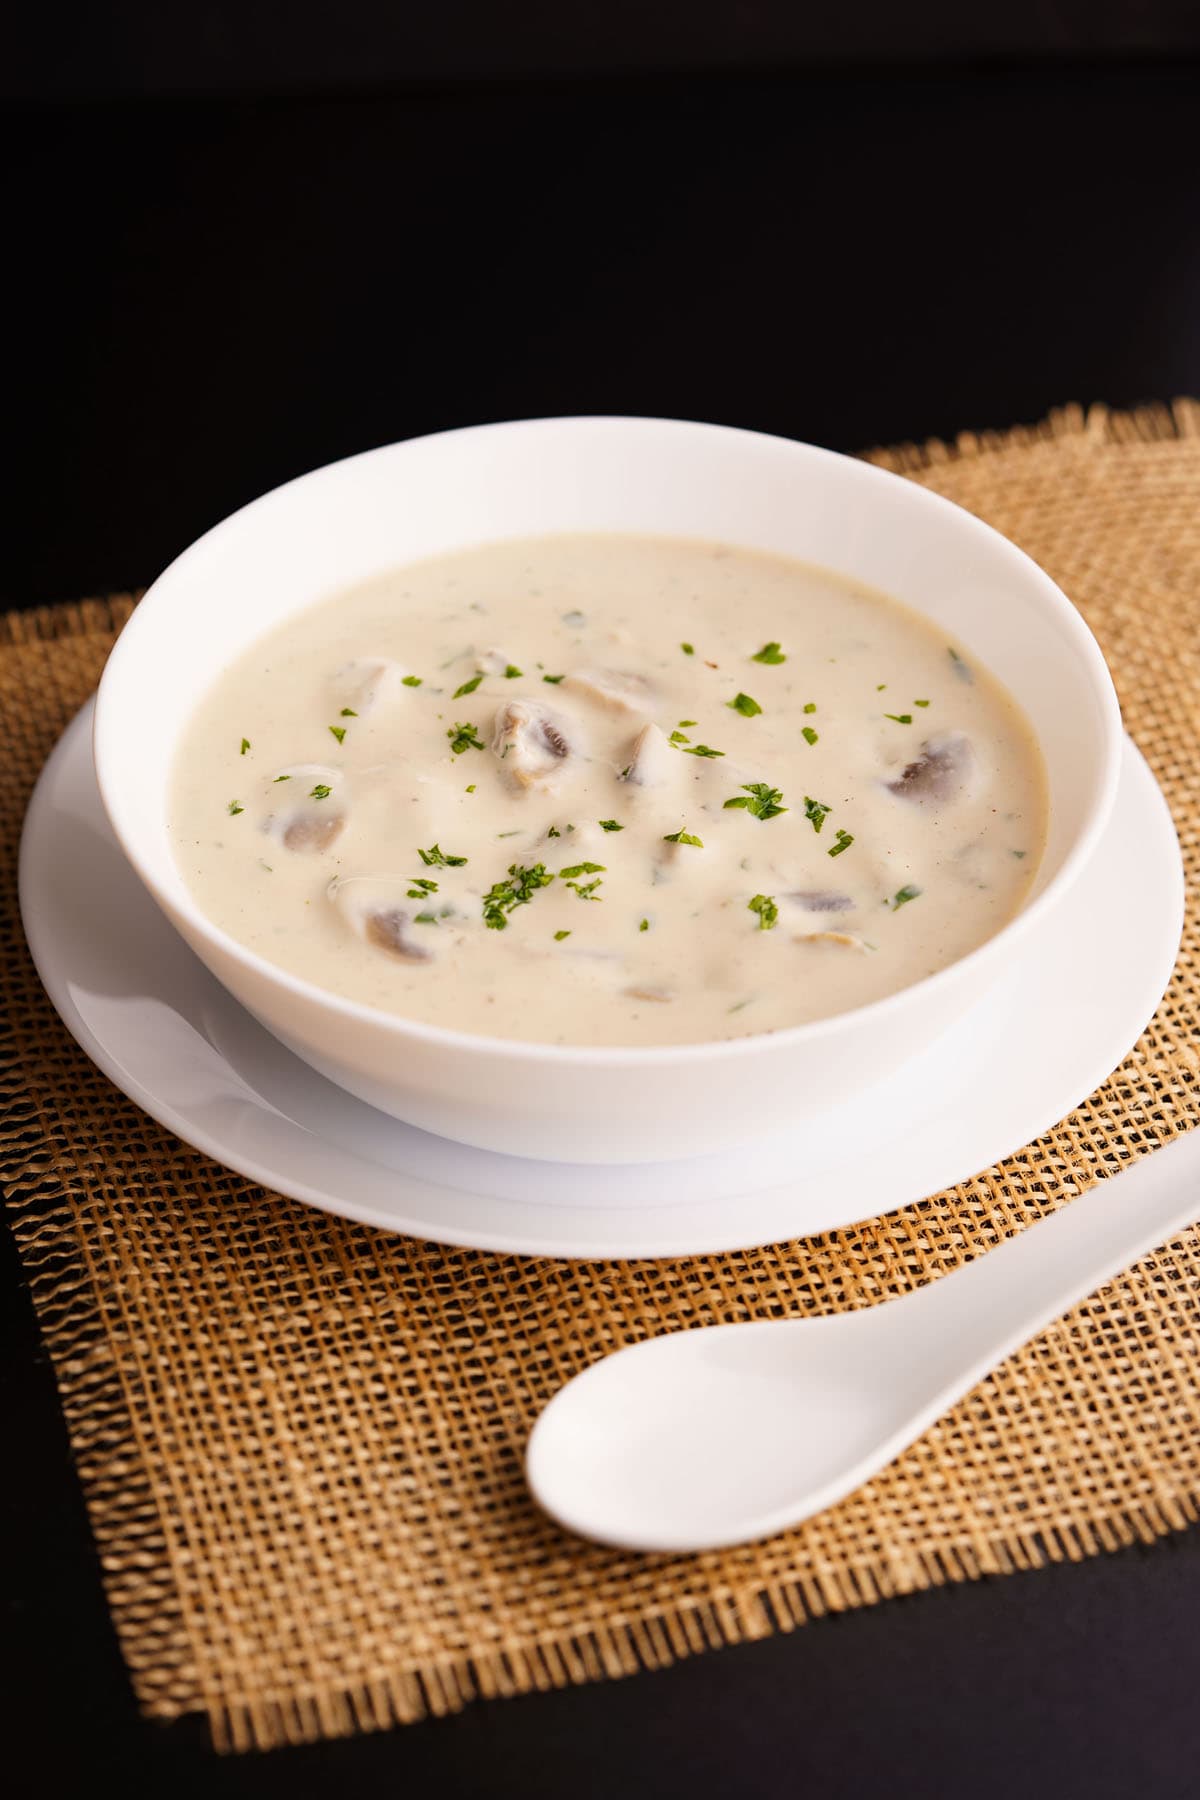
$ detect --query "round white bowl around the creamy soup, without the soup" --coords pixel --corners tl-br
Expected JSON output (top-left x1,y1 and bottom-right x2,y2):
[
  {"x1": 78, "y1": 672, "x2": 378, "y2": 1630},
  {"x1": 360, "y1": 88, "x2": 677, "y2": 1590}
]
[{"x1": 94, "y1": 418, "x2": 1121, "y2": 1163}]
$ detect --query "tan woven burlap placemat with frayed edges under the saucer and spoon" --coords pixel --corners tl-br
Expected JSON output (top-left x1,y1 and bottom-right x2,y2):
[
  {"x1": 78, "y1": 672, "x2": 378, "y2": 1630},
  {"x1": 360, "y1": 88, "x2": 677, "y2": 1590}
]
[{"x1": 0, "y1": 403, "x2": 1200, "y2": 1748}]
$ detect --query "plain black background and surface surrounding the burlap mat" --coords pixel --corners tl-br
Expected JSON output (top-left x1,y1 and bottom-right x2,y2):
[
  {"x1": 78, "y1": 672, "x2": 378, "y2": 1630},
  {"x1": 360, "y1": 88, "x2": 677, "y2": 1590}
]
[{"x1": 0, "y1": 0, "x2": 1200, "y2": 1800}]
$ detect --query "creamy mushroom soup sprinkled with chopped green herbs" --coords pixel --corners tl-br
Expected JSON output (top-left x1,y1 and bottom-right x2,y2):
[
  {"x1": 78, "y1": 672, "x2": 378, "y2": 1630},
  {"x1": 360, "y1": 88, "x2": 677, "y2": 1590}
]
[{"x1": 171, "y1": 535, "x2": 1047, "y2": 1044}]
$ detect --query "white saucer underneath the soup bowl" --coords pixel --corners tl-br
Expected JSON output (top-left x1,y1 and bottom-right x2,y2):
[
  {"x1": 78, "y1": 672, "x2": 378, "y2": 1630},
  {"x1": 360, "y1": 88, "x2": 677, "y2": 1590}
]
[{"x1": 20, "y1": 704, "x2": 1184, "y2": 1256}]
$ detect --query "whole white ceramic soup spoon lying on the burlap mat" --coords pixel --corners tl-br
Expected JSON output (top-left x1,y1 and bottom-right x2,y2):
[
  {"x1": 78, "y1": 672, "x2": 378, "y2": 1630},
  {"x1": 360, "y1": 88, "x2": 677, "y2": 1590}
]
[{"x1": 525, "y1": 1130, "x2": 1200, "y2": 1552}]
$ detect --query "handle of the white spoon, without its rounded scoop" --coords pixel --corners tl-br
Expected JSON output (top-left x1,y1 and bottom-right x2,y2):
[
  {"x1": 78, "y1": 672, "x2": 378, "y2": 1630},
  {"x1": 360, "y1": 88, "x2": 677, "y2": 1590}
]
[{"x1": 900, "y1": 1130, "x2": 1200, "y2": 1393}]
